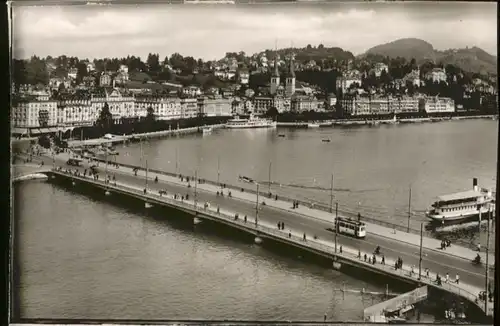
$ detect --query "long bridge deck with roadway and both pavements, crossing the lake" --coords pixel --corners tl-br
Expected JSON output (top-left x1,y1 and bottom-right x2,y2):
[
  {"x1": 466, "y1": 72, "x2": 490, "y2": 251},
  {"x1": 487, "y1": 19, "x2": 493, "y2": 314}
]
[{"x1": 13, "y1": 154, "x2": 494, "y2": 315}]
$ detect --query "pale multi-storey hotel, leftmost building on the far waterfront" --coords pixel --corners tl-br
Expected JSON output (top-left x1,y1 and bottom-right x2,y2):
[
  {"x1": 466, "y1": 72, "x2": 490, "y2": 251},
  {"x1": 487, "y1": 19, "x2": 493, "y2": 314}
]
[{"x1": 11, "y1": 96, "x2": 57, "y2": 128}]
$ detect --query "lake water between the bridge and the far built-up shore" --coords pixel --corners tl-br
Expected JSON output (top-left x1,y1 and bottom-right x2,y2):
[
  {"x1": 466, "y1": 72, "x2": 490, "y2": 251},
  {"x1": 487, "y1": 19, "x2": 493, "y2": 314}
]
[{"x1": 117, "y1": 120, "x2": 498, "y2": 242}]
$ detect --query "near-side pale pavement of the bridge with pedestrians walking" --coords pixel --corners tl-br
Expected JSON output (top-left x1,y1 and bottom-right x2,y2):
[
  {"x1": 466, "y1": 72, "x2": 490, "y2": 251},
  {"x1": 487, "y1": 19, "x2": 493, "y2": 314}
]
[{"x1": 48, "y1": 167, "x2": 493, "y2": 315}]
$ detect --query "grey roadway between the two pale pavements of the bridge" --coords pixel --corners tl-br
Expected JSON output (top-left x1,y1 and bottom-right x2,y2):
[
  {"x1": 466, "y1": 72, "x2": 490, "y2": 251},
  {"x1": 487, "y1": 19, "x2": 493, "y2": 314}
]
[{"x1": 42, "y1": 156, "x2": 494, "y2": 288}]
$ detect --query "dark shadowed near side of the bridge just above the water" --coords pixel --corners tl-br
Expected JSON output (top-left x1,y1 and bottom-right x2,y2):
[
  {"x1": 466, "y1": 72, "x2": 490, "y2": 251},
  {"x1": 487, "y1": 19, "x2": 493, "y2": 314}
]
[{"x1": 42, "y1": 171, "x2": 487, "y2": 318}]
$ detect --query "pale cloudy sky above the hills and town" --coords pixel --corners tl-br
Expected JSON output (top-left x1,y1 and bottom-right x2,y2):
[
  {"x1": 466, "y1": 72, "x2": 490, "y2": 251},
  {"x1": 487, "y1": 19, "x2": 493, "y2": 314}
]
[{"x1": 11, "y1": 2, "x2": 497, "y2": 60}]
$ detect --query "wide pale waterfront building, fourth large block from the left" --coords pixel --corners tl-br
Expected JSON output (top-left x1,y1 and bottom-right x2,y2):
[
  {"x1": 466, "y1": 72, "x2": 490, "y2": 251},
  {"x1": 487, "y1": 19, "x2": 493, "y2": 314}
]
[{"x1": 134, "y1": 96, "x2": 182, "y2": 120}]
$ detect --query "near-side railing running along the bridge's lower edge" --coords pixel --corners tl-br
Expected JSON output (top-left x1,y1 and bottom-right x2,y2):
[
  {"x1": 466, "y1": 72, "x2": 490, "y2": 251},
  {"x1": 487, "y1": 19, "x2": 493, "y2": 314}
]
[{"x1": 53, "y1": 170, "x2": 484, "y2": 310}]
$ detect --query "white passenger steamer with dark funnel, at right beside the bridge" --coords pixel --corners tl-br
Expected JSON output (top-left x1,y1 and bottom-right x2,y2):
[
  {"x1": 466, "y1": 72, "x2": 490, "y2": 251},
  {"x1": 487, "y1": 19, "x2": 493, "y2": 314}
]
[{"x1": 426, "y1": 178, "x2": 495, "y2": 224}]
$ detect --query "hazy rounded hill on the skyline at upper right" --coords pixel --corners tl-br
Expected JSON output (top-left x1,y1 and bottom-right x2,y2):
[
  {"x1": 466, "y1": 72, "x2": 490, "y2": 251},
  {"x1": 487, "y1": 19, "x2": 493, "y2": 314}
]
[{"x1": 361, "y1": 38, "x2": 497, "y2": 74}]
